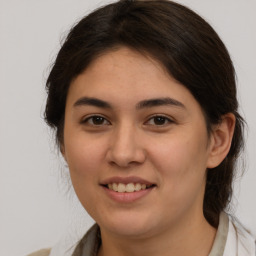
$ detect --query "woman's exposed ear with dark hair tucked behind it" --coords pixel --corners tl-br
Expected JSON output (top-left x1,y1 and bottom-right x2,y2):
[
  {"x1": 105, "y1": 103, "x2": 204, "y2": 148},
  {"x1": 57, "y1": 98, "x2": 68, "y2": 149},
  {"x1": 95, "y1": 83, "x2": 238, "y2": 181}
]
[{"x1": 207, "y1": 113, "x2": 236, "y2": 168}]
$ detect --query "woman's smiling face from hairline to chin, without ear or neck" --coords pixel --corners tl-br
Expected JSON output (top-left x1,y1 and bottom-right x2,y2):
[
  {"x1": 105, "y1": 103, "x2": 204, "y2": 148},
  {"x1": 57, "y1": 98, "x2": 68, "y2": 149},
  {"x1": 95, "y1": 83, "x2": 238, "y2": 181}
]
[{"x1": 63, "y1": 48, "x2": 215, "y2": 237}]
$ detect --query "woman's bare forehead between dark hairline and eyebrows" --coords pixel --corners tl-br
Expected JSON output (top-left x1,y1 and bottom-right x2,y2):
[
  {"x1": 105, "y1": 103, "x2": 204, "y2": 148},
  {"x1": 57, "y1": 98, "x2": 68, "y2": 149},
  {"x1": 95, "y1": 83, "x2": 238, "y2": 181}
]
[{"x1": 68, "y1": 47, "x2": 202, "y2": 113}]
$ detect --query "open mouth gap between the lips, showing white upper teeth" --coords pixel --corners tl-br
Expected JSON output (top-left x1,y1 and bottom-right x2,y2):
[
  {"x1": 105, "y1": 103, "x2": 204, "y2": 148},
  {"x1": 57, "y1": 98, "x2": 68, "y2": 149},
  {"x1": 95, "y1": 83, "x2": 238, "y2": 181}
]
[{"x1": 102, "y1": 182, "x2": 156, "y2": 193}]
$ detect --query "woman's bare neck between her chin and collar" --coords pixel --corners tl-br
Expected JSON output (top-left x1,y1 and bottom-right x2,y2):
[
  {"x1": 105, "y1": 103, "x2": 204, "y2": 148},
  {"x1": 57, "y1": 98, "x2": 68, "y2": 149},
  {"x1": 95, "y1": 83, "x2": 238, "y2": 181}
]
[{"x1": 98, "y1": 212, "x2": 216, "y2": 256}]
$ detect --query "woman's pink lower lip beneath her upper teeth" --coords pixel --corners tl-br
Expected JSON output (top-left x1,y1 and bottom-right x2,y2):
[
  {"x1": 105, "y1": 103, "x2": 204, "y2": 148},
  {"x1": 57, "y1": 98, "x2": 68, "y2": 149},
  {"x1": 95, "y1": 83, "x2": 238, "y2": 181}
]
[{"x1": 102, "y1": 187, "x2": 154, "y2": 203}]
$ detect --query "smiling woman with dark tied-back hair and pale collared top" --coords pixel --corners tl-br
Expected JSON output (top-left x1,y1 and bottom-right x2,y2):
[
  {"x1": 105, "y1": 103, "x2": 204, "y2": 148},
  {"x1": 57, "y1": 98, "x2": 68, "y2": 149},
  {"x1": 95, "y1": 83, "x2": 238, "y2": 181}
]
[{"x1": 29, "y1": 0, "x2": 255, "y2": 256}]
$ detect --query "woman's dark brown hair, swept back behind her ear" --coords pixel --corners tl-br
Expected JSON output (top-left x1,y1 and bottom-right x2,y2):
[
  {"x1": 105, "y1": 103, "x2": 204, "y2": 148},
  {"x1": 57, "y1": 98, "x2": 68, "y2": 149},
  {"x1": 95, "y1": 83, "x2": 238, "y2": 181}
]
[{"x1": 45, "y1": 0, "x2": 244, "y2": 227}]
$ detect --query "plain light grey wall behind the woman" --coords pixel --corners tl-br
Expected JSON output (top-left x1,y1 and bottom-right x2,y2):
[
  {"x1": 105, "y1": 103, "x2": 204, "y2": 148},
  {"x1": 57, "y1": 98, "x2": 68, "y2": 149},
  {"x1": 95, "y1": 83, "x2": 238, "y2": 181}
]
[{"x1": 0, "y1": 0, "x2": 256, "y2": 256}]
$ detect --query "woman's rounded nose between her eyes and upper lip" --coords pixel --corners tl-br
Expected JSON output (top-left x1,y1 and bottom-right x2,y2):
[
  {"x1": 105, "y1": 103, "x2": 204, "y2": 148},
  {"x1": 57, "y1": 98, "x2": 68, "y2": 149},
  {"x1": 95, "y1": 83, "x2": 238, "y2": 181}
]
[{"x1": 107, "y1": 124, "x2": 146, "y2": 168}]
